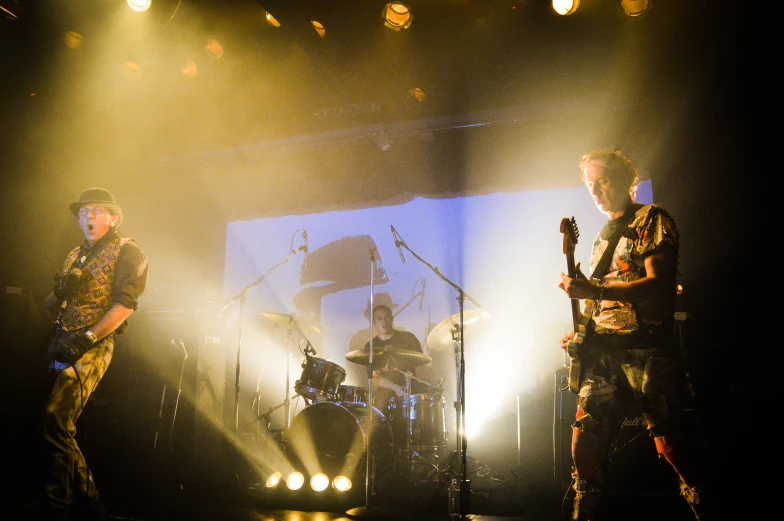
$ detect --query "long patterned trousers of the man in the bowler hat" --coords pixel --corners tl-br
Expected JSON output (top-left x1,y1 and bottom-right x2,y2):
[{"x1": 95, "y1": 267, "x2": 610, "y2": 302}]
[{"x1": 43, "y1": 335, "x2": 114, "y2": 512}]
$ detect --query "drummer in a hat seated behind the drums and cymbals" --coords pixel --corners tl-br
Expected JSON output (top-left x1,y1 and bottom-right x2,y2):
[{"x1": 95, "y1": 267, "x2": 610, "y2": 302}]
[{"x1": 365, "y1": 293, "x2": 431, "y2": 403}]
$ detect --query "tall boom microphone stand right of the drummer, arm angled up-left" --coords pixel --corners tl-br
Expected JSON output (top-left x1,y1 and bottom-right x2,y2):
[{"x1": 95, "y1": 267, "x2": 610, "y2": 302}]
[{"x1": 396, "y1": 228, "x2": 482, "y2": 515}]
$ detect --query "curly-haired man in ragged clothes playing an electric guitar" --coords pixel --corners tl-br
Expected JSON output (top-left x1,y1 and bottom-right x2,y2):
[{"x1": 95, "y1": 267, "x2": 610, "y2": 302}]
[{"x1": 558, "y1": 149, "x2": 710, "y2": 521}]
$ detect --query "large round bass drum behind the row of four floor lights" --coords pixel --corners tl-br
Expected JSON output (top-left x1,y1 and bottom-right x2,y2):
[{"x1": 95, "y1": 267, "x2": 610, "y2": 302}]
[{"x1": 287, "y1": 402, "x2": 395, "y2": 488}]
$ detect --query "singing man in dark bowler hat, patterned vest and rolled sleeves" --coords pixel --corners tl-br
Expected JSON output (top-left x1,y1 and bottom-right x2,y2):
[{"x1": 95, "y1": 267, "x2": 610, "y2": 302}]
[{"x1": 43, "y1": 188, "x2": 147, "y2": 520}]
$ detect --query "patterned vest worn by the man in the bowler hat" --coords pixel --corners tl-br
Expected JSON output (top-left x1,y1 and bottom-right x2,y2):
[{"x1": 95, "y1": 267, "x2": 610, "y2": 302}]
[{"x1": 60, "y1": 237, "x2": 132, "y2": 331}]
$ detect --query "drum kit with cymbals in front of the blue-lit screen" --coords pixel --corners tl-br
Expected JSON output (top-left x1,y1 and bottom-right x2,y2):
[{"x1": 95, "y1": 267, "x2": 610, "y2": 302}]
[{"x1": 260, "y1": 302, "x2": 488, "y2": 486}]
